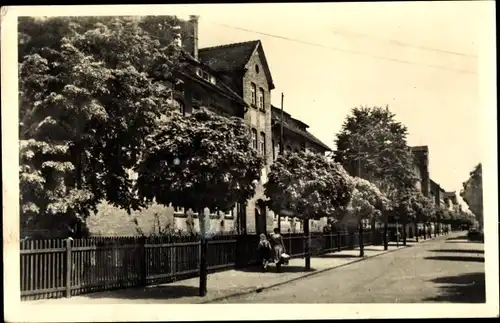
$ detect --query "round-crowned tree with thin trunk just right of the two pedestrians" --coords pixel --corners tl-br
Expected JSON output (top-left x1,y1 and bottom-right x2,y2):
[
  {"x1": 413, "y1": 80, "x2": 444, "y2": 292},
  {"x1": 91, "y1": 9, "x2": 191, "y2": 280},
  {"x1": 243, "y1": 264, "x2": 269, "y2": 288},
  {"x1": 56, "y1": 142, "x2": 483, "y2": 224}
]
[{"x1": 264, "y1": 151, "x2": 353, "y2": 269}]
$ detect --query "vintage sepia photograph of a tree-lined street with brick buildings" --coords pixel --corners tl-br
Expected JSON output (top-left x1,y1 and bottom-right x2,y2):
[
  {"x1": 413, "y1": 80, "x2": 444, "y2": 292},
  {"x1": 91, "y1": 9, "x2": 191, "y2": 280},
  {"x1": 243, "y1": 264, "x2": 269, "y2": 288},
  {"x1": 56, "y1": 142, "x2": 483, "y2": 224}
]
[{"x1": 2, "y1": 1, "x2": 498, "y2": 320}]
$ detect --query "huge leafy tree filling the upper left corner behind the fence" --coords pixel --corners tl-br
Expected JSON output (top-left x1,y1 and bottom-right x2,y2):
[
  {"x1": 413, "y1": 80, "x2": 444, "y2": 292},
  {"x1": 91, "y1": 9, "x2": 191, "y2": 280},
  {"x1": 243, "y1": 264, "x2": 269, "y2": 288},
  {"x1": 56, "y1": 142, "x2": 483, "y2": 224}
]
[{"x1": 18, "y1": 16, "x2": 184, "y2": 234}]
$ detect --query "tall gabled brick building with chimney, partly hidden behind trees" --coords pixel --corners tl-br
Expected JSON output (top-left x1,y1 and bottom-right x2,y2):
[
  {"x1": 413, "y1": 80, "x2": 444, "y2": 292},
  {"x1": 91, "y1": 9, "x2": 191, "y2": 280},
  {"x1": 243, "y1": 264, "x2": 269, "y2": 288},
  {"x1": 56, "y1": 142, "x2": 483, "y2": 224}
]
[{"x1": 90, "y1": 16, "x2": 329, "y2": 237}]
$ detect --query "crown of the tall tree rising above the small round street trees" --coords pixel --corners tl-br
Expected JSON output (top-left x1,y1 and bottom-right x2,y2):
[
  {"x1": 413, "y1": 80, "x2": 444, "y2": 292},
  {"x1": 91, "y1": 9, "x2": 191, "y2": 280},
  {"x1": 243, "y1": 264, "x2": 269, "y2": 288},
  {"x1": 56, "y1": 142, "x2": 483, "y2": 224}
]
[{"x1": 334, "y1": 107, "x2": 417, "y2": 196}]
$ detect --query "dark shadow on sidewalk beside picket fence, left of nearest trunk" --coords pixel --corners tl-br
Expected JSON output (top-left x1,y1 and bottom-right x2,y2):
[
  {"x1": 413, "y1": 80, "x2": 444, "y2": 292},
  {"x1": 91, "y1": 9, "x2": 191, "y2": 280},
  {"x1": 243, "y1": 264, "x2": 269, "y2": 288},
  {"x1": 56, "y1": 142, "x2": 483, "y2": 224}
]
[{"x1": 85, "y1": 285, "x2": 199, "y2": 299}]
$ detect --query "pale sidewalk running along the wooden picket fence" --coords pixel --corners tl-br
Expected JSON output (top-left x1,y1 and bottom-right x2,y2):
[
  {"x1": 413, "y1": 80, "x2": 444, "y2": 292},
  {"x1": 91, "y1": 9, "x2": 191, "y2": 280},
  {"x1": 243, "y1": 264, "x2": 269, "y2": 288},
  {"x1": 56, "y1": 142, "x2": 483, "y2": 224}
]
[{"x1": 22, "y1": 235, "x2": 450, "y2": 305}]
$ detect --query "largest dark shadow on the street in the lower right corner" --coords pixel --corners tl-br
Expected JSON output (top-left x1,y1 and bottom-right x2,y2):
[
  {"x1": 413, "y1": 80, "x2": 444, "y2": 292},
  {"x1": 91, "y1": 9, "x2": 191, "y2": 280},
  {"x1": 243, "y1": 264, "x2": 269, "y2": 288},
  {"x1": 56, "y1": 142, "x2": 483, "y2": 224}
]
[{"x1": 423, "y1": 272, "x2": 486, "y2": 303}]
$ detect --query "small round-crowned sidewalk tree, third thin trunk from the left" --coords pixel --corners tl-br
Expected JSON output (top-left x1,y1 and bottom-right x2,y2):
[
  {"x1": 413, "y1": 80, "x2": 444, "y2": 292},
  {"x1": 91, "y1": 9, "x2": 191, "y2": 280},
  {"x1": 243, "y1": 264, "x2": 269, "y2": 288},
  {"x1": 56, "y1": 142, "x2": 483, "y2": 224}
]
[{"x1": 347, "y1": 177, "x2": 386, "y2": 257}]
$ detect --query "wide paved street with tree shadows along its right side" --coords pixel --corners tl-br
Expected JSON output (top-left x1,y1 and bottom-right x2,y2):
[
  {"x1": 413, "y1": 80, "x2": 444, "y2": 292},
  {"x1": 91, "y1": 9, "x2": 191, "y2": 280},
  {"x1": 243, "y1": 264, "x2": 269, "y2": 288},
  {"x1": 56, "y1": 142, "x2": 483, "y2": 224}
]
[{"x1": 214, "y1": 233, "x2": 485, "y2": 303}]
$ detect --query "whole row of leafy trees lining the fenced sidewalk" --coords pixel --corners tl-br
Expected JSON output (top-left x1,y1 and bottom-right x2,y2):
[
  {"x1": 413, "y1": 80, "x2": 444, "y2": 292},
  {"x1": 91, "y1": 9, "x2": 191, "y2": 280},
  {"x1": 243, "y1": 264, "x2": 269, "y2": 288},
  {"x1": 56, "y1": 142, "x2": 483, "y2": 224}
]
[{"x1": 19, "y1": 16, "x2": 472, "y2": 295}]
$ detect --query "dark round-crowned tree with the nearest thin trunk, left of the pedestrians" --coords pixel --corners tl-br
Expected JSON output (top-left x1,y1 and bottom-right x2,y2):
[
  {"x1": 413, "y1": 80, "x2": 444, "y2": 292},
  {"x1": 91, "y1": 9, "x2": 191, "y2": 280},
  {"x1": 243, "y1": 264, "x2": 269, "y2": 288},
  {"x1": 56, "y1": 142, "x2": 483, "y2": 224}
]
[{"x1": 136, "y1": 109, "x2": 264, "y2": 296}]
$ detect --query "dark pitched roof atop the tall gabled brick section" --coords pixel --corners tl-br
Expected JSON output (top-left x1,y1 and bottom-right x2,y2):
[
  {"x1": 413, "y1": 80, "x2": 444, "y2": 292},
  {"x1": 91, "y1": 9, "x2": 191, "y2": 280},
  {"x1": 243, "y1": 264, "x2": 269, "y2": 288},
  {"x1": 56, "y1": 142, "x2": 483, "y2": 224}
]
[{"x1": 198, "y1": 40, "x2": 274, "y2": 90}]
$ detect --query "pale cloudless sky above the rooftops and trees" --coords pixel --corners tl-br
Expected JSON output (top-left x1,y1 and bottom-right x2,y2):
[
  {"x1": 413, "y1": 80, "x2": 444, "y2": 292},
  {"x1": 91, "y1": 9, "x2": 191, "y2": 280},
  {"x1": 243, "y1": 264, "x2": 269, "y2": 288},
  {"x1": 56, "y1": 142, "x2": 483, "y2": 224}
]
[{"x1": 170, "y1": 1, "x2": 490, "y2": 202}]
